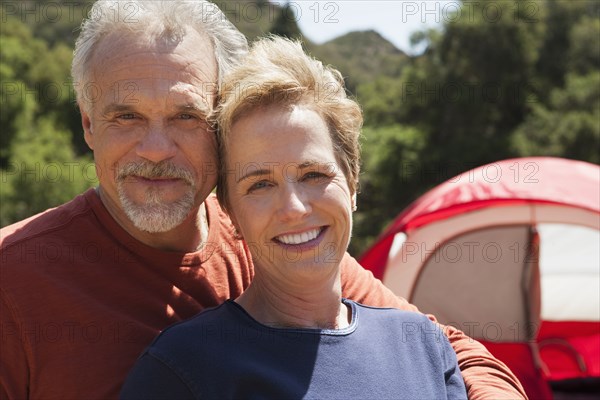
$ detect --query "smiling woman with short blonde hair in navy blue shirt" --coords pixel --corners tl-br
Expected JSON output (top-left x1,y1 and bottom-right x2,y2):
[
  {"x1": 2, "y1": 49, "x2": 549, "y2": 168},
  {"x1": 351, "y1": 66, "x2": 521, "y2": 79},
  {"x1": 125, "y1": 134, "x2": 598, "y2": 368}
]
[{"x1": 121, "y1": 38, "x2": 466, "y2": 399}]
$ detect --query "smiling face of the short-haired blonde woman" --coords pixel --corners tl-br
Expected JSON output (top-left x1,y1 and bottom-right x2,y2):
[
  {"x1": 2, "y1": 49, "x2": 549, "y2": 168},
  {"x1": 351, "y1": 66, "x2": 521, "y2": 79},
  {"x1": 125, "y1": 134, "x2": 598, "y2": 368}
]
[{"x1": 226, "y1": 105, "x2": 353, "y2": 284}]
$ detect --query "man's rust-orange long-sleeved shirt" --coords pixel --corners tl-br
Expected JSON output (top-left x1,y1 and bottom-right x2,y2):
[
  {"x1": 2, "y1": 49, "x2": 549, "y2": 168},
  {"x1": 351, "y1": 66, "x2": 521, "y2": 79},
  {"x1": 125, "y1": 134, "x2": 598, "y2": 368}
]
[{"x1": 0, "y1": 189, "x2": 525, "y2": 399}]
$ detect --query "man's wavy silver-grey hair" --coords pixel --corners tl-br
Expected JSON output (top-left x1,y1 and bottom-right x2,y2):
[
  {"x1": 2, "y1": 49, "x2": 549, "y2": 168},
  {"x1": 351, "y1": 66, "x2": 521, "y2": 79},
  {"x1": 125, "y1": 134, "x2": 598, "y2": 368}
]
[{"x1": 71, "y1": 0, "x2": 248, "y2": 110}]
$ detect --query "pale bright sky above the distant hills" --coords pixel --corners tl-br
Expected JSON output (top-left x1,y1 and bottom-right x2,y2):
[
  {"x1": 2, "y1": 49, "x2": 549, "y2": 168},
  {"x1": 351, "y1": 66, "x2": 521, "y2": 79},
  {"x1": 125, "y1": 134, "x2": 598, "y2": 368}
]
[{"x1": 282, "y1": 0, "x2": 459, "y2": 54}]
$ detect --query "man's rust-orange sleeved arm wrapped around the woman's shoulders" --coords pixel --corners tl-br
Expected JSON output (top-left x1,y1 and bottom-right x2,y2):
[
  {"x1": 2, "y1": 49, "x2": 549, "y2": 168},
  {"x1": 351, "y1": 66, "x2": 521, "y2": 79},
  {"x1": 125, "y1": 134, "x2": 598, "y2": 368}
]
[{"x1": 342, "y1": 254, "x2": 527, "y2": 399}]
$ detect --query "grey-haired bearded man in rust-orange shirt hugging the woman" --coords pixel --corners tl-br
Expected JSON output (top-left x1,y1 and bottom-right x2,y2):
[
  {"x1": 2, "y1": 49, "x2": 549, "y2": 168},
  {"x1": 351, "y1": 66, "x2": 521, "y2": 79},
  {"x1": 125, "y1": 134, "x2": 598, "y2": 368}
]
[{"x1": 0, "y1": 0, "x2": 524, "y2": 399}]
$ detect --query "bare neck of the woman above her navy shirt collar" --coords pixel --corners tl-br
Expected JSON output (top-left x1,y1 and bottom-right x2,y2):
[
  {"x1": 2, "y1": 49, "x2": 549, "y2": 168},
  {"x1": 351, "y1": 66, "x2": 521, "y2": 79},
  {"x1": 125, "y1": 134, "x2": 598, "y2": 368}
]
[{"x1": 235, "y1": 271, "x2": 351, "y2": 329}]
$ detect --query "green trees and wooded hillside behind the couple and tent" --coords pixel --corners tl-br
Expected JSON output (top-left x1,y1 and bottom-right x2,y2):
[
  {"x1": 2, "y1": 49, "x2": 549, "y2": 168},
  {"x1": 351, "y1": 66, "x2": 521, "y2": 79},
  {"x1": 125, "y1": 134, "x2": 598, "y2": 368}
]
[{"x1": 0, "y1": 0, "x2": 600, "y2": 254}]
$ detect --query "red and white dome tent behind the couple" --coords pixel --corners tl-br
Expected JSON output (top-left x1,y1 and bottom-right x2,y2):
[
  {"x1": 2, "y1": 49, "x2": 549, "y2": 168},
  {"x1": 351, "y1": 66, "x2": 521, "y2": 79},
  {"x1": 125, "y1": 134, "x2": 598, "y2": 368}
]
[{"x1": 360, "y1": 157, "x2": 600, "y2": 398}]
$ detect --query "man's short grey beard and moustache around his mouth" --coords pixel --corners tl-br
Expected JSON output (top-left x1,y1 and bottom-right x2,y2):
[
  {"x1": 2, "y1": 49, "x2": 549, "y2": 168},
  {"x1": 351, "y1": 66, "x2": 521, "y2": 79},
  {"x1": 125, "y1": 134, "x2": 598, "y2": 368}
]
[{"x1": 117, "y1": 162, "x2": 195, "y2": 233}]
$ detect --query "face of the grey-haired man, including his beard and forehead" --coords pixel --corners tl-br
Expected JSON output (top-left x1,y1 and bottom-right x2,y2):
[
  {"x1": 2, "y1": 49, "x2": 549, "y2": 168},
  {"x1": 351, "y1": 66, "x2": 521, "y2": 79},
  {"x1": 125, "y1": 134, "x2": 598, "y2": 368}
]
[{"x1": 82, "y1": 31, "x2": 217, "y2": 232}]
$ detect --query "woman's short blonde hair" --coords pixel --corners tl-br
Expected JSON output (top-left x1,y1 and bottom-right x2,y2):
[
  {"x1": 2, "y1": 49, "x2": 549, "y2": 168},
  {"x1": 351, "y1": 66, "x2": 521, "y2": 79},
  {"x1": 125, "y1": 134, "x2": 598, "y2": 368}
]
[{"x1": 214, "y1": 36, "x2": 363, "y2": 210}]
